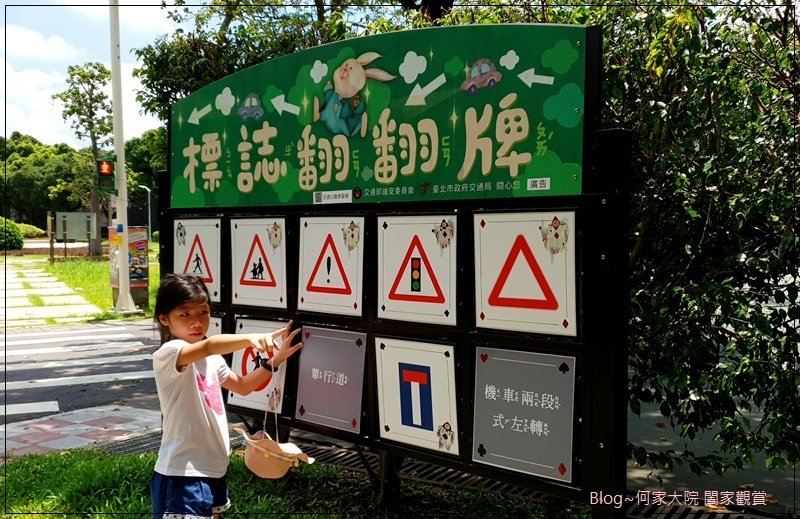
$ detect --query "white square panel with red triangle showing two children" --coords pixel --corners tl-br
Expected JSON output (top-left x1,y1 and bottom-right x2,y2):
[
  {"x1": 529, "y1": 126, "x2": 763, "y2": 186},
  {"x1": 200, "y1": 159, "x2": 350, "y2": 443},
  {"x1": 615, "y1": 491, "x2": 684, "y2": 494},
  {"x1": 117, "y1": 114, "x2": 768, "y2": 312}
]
[{"x1": 231, "y1": 218, "x2": 287, "y2": 308}]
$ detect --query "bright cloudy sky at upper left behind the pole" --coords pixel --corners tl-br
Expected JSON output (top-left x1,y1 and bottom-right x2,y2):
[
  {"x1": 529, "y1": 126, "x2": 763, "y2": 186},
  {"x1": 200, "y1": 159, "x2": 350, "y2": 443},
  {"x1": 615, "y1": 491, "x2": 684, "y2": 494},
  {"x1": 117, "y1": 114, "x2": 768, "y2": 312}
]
[{"x1": 0, "y1": 0, "x2": 187, "y2": 149}]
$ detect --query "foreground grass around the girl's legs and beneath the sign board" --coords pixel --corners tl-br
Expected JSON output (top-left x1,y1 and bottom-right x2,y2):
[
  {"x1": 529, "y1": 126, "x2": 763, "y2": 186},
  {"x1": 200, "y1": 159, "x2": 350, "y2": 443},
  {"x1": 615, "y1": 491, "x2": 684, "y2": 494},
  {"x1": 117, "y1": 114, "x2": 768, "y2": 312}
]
[{"x1": 2, "y1": 448, "x2": 568, "y2": 519}]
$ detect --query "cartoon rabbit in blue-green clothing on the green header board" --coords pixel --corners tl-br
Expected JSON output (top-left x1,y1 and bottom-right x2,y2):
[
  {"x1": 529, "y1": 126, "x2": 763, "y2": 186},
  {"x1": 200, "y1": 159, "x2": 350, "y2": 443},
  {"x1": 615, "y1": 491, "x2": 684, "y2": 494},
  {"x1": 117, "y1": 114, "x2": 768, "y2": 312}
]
[{"x1": 314, "y1": 52, "x2": 397, "y2": 137}]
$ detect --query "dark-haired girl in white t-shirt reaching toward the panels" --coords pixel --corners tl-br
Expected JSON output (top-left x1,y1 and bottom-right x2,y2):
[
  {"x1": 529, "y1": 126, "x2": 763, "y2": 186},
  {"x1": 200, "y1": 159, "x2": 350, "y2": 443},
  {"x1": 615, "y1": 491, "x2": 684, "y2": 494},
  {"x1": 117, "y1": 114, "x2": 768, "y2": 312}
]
[{"x1": 150, "y1": 274, "x2": 303, "y2": 519}]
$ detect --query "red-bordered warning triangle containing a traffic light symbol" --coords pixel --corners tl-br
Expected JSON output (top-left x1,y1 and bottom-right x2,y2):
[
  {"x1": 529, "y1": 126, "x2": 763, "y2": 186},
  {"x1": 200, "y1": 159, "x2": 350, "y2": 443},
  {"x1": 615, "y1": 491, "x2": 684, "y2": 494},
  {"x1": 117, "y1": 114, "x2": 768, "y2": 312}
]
[{"x1": 388, "y1": 234, "x2": 445, "y2": 304}]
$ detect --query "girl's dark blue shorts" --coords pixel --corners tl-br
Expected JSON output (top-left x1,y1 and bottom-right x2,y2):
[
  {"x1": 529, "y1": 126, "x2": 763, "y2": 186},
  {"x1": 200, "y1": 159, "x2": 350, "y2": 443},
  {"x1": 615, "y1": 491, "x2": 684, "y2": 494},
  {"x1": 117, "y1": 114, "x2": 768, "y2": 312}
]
[{"x1": 150, "y1": 472, "x2": 231, "y2": 519}]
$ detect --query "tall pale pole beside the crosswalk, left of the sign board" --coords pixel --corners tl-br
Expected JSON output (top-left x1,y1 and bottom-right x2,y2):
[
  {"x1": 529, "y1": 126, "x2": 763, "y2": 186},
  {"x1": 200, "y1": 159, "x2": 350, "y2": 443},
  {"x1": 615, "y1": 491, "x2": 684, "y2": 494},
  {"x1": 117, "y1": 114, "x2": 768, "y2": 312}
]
[{"x1": 108, "y1": 0, "x2": 140, "y2": 313}]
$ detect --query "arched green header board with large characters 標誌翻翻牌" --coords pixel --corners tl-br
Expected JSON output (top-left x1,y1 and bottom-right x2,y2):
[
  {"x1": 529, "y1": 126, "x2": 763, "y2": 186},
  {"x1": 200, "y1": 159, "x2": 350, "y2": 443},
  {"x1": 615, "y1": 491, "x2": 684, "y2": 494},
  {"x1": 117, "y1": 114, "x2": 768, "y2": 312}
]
[{"x1": 171, "y1": 25, "x2": 587, "y2": 208}]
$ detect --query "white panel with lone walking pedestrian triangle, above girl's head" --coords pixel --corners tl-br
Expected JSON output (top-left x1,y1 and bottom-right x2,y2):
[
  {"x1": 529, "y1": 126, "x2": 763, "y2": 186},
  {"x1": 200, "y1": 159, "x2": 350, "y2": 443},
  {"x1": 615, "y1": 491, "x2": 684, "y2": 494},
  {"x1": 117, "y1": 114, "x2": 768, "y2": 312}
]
[{"x1": 173, "y1": 218, "x2": 221, "y2": 303}]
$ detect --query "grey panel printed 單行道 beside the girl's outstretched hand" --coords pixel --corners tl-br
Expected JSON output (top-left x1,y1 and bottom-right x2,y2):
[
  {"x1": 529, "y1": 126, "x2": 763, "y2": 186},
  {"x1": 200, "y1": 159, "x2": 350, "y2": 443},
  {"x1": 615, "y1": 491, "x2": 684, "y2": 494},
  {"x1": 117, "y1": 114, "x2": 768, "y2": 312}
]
[{"x1": 295, "y1": 326, "x2": 367, "y2": 434}]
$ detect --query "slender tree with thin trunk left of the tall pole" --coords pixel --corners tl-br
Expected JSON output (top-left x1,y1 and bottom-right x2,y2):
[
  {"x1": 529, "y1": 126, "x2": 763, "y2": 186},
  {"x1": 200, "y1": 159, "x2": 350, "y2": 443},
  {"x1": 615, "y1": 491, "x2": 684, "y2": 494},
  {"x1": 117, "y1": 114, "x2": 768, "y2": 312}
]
[{"x1": 53, "y1": 62, "x2": 113, "y2": 257}]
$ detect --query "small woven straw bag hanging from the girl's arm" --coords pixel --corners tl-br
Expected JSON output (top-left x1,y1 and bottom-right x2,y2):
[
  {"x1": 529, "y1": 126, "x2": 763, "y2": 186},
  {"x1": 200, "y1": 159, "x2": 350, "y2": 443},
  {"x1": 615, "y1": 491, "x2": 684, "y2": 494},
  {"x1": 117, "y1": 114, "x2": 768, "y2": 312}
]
[{"x1": 233, "y1": 358, "x2": 314, "y2": 479}]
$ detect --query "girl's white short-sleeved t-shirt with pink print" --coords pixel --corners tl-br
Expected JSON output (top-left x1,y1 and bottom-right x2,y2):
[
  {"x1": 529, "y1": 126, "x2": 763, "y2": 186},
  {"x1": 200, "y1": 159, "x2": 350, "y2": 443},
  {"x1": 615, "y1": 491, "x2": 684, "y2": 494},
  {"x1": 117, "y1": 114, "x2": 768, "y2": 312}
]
[{"x1": 153, "y1": 340, "x2": 231, "y2": 478}]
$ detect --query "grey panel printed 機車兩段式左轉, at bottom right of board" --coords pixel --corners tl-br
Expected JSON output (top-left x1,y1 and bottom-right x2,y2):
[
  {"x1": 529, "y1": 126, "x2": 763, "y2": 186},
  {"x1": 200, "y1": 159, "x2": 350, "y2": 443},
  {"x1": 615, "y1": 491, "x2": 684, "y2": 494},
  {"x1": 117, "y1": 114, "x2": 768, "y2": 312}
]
[{"x1": 472, "y1": 347, "x2": 575, "y2": 483}]
